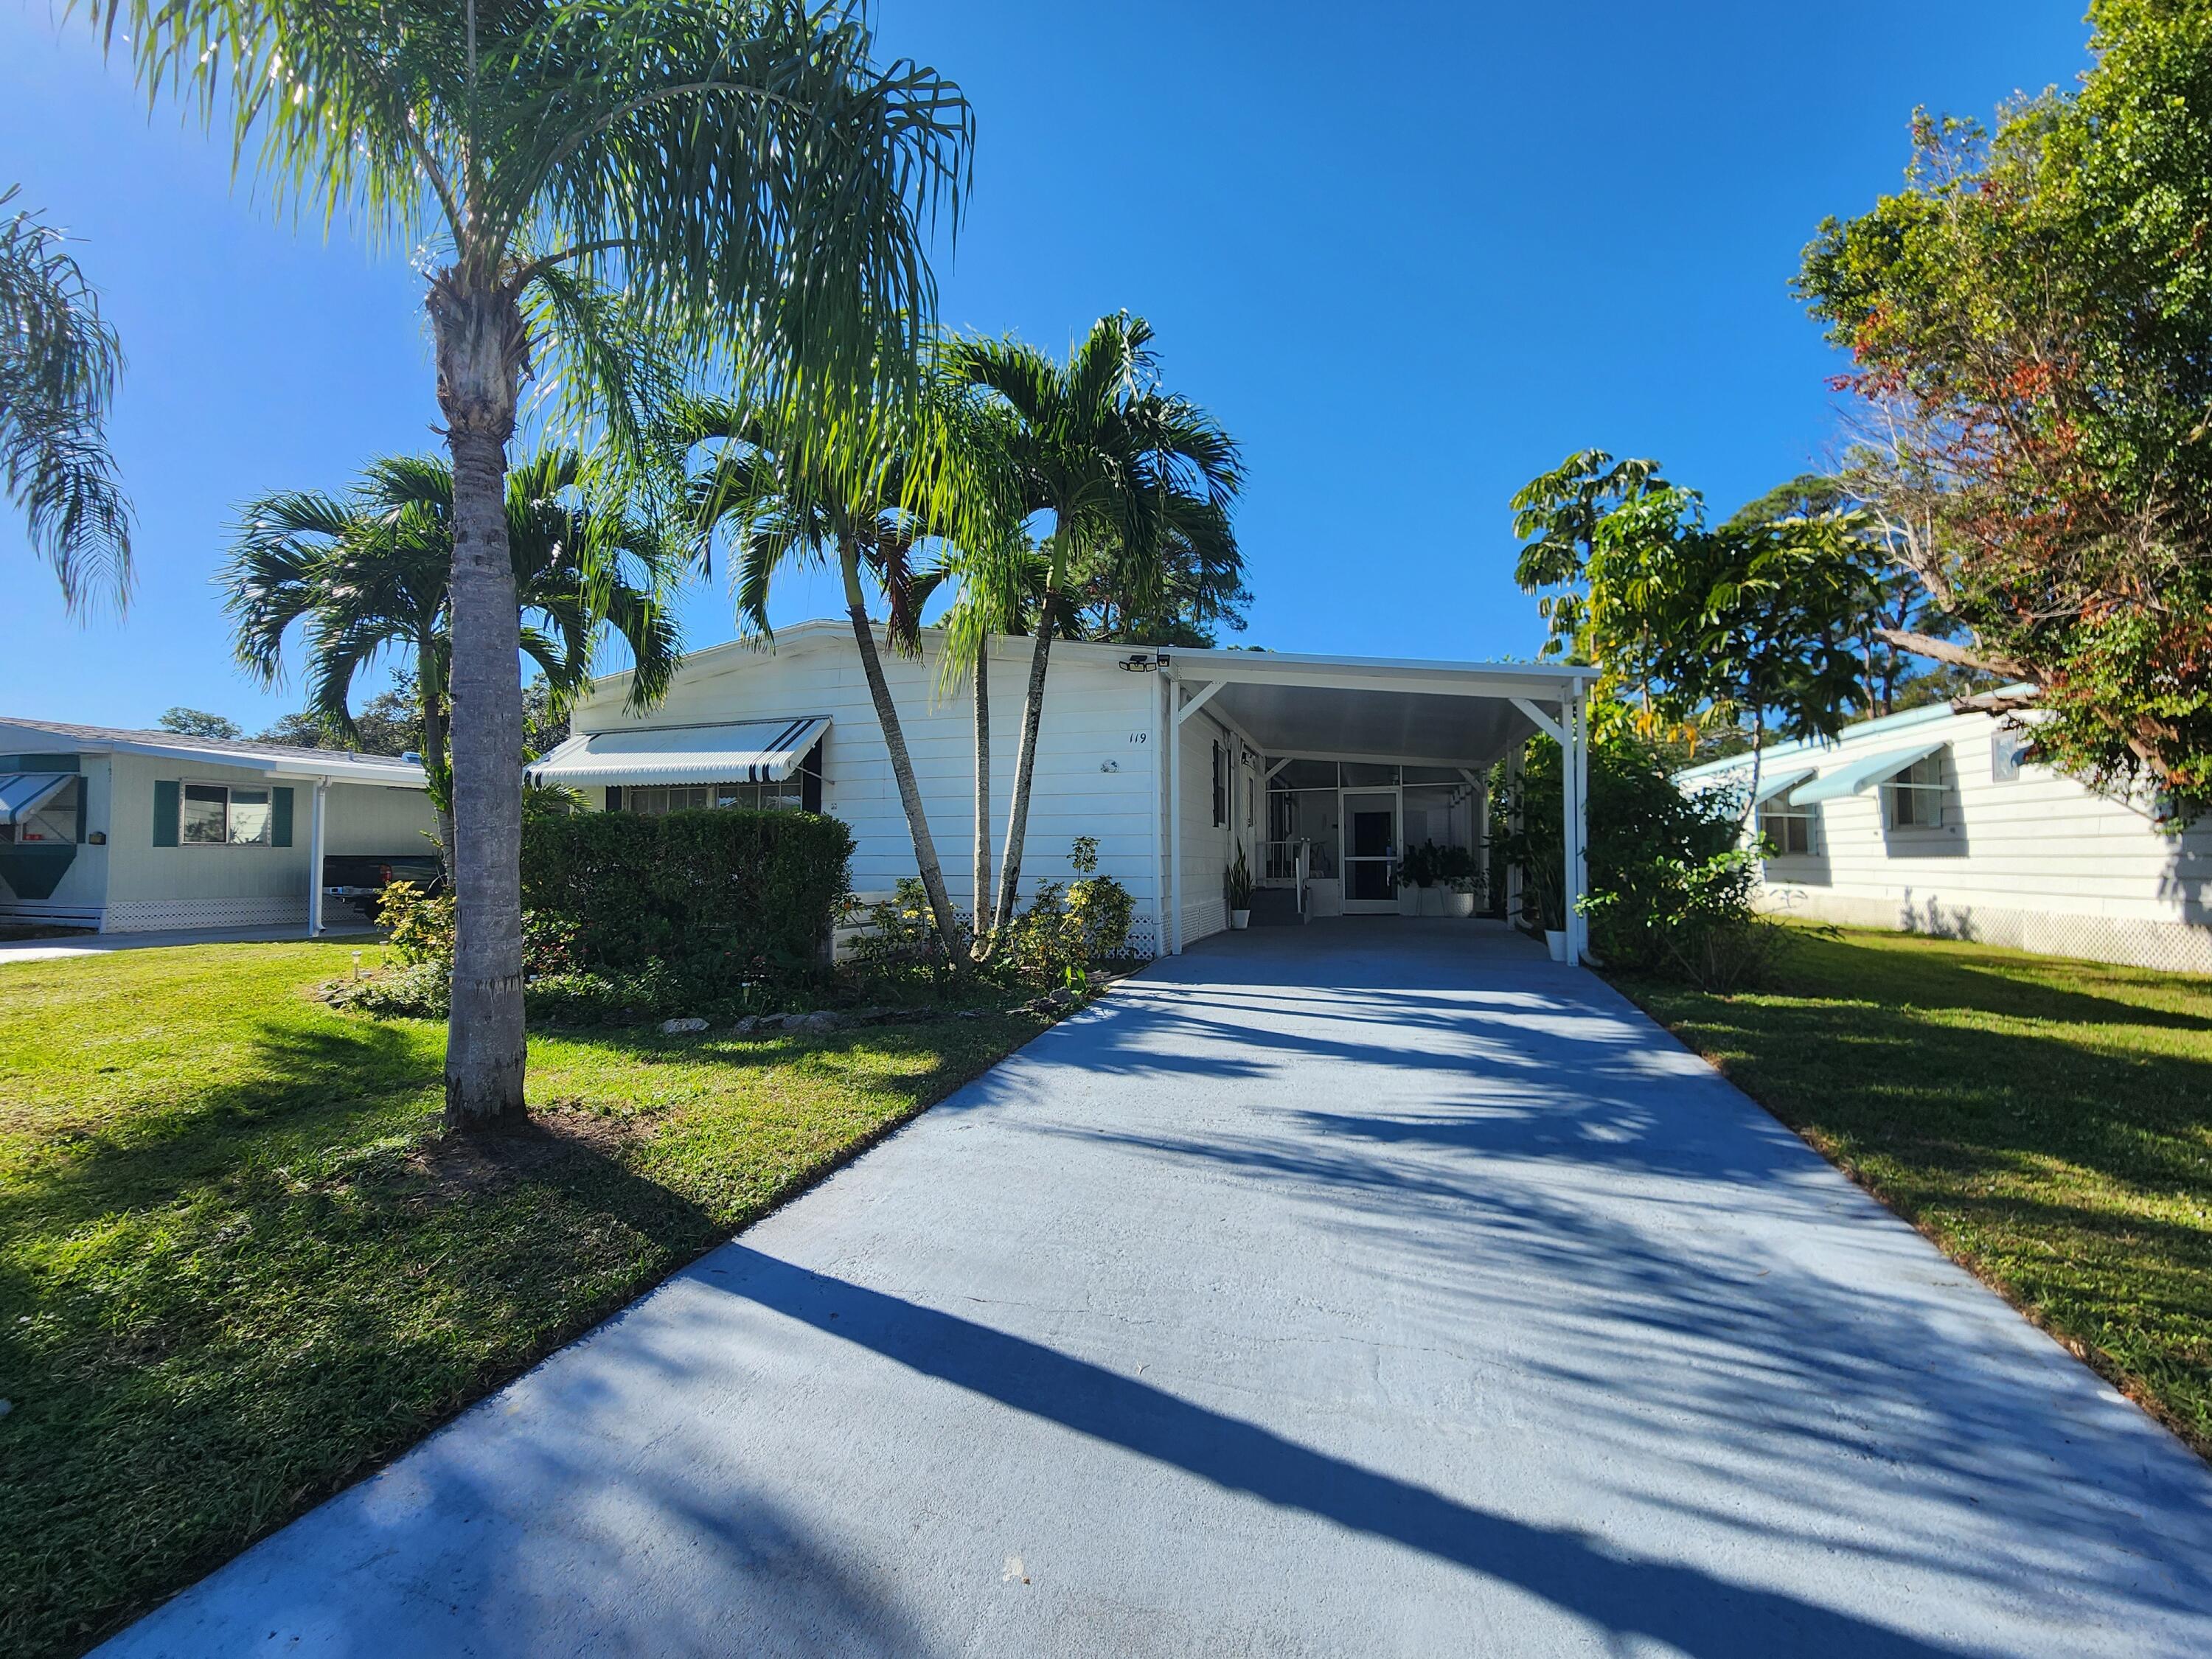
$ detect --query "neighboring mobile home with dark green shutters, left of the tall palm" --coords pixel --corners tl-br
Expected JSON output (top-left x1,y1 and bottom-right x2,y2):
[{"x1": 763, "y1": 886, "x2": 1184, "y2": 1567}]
[{"x1": 0, "y1": 717, "x2": 434, "y2": 933}]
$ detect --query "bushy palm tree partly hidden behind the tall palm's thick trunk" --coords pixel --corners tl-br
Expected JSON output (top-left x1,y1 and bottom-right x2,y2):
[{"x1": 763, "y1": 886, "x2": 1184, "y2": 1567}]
[{"x1": 223, "y1": 449, "x2": 684, "y2": 876}]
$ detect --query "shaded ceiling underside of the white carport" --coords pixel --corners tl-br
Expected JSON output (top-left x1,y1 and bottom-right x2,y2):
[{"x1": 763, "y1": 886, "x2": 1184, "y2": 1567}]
[{"x1": 1208, "y1": 681, "x2": 1535, "y2": 765}]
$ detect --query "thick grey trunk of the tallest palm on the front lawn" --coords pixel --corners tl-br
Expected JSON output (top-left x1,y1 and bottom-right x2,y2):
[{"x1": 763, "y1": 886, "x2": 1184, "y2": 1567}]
[{"x1": 429, "y1": 272, "x2": 526, "y2": 1128}]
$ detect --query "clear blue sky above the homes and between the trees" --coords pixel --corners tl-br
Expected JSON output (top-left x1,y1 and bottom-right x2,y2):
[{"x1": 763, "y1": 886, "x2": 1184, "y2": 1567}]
[{"x1": 0, "y1": 0, "x2": 2086, "y2": 730}]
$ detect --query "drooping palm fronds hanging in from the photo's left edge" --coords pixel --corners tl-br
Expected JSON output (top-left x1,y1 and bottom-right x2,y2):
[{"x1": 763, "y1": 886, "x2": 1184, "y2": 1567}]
[{"x1": 0, "y1": 184, "x2": 131, "y2": 611}]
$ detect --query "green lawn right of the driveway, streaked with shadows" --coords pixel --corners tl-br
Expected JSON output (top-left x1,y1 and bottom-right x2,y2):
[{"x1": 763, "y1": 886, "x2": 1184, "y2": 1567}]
[{"x1": 1621, "y1": 929, "x2": 2212, "y2": 1455}]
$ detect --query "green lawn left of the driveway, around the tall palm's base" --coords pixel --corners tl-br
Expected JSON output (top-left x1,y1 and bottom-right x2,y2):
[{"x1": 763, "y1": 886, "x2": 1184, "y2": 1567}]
[{"x1": 0, "y1": 942, "x2": 1040, "y2": 1655}]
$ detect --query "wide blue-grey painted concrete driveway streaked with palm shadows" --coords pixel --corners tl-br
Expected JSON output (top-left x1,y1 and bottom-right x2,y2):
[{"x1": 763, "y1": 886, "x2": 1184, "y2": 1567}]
[{"x1": 113, "y1": 920, "x2": 2212, "y2": 1659}]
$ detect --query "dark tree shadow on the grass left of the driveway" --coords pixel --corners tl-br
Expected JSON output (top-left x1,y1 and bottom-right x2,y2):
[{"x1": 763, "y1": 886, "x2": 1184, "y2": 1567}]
[{"x1": 0, "y1": 1110, "x2": 728, "y2": 1655}]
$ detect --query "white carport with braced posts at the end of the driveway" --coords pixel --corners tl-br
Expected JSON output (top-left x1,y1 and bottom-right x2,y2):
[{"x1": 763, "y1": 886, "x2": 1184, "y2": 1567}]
[{"x1": 1126, "y1": 650, "x2": 1597, "y2": 962}]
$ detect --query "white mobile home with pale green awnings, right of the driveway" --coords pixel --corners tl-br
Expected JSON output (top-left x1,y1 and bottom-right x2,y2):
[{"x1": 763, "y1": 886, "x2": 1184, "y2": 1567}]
[{"x1": 1677, "y1": 703, "x2": 2212, "y2": 973}]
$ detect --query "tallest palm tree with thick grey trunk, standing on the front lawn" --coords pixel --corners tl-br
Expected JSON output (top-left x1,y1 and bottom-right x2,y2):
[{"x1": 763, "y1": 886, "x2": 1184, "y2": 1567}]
[{"x1": 86, "y1": 0, "x2": 973, "y2": 1128}]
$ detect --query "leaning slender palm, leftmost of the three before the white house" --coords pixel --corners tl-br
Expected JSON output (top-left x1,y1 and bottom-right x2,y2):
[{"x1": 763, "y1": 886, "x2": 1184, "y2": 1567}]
[{"x1": 675, "y1": 400, "x2": 967, "y2": 971}]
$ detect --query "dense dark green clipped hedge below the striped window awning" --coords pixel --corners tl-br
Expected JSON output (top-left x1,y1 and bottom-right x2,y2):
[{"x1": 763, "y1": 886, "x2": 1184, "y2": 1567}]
[{"x1": 522, "y1": 807, "x2": 852, "y2": 971}]
